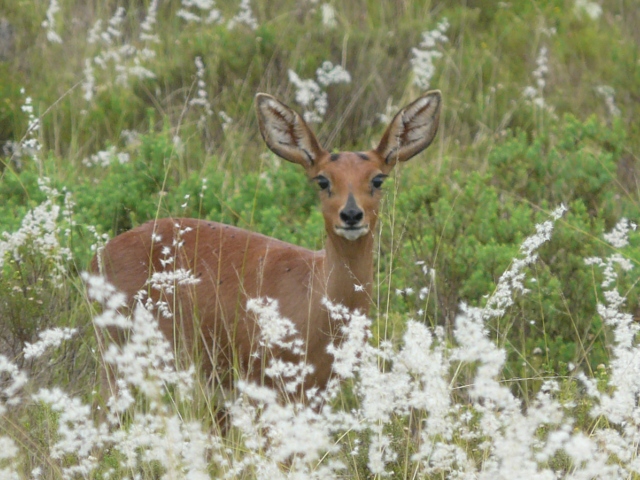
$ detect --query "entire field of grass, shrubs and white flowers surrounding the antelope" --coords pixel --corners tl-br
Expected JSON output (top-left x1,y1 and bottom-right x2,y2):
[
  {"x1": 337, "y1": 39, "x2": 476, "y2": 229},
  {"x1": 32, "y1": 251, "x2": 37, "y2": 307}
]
[{"x1": 0, "y1": 0, "x2": 640, "y2": 479}]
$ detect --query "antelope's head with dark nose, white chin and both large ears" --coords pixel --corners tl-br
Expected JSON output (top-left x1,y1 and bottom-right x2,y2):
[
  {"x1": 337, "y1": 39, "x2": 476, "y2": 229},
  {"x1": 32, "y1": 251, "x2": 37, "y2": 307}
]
[{"x1": 256, "y1": 90, "x2": 441, "y2": 242}]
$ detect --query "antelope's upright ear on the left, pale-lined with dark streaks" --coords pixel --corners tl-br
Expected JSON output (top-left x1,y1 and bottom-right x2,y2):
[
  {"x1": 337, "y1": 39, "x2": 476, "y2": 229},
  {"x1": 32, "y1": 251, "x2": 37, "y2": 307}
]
[{"x1": 256, "y1": 93, "x2": 325, "y2": 168}]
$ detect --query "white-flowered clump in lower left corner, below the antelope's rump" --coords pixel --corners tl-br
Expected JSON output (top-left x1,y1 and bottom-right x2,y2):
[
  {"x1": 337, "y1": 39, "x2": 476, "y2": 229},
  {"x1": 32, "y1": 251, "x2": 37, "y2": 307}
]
[{"x1": 6, "y1": 275, "x2": 219, "y2": 478}]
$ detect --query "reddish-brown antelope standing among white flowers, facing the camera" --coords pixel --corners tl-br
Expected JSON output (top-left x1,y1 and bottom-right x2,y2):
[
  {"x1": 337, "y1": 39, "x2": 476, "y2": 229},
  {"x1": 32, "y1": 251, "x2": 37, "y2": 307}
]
[{"x1": 92, "y1": 92, "x2": 440, "y2": 400}]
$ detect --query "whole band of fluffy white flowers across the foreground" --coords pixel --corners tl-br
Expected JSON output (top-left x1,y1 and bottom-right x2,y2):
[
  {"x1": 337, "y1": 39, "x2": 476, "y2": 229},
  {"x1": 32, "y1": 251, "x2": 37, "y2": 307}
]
[{"x1": 0, "y1": 171, "x2": 640, "y2": 479}]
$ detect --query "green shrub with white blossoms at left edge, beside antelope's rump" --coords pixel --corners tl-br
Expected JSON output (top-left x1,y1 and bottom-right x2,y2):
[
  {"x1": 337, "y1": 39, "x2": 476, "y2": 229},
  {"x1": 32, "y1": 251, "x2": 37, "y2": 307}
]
[{"x1": 0, "y1": 178, "x2": 95, "y2": 412}]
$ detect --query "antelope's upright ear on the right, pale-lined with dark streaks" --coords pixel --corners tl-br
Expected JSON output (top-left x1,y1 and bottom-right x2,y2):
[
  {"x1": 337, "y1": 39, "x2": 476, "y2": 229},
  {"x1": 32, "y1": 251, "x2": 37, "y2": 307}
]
[{"x1": 376, "y1": 90, "x2": 442, "y2": 165}]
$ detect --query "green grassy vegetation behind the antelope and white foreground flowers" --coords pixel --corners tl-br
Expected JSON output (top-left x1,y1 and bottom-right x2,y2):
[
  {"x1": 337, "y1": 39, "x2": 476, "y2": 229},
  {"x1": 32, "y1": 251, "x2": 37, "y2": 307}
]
[{"x1": 0, "y1": 0, "x2": 640, "y2": 478}]
